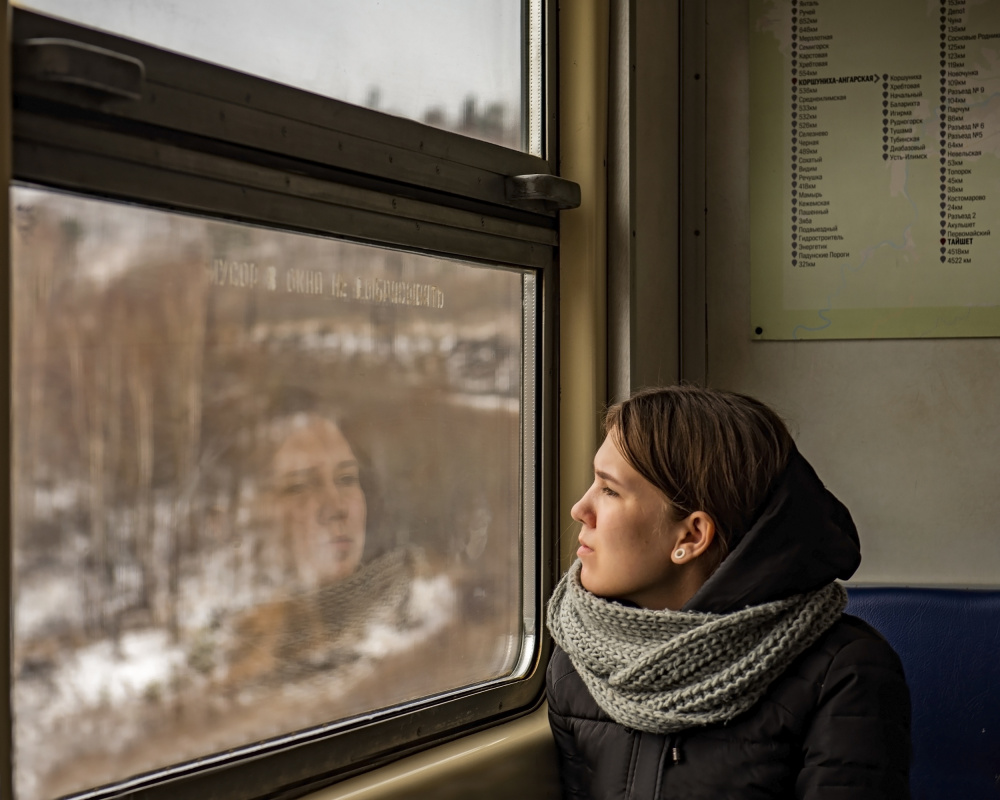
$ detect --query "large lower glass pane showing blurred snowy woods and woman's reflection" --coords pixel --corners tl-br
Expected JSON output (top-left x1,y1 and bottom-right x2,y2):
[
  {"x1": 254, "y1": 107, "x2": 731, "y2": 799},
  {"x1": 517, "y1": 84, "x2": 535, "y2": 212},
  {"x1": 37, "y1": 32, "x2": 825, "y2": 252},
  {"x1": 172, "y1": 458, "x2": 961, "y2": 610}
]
[{"x1": 12, "y1": 186, "x2": 535, "y2": 800}]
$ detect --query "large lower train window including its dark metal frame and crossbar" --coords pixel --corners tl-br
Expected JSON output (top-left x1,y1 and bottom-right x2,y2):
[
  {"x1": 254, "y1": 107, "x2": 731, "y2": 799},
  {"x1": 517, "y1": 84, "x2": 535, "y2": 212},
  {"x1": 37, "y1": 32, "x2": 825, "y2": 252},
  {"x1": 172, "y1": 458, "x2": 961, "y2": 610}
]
[{"x1": 10, "y1": 8, "x2": 573, "y2": 800}]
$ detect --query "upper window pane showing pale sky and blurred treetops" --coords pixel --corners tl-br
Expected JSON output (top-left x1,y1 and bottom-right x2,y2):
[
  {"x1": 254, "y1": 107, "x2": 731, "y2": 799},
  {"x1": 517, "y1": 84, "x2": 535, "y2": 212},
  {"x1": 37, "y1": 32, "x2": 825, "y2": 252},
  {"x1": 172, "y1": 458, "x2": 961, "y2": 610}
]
[{"x1": 15, "y1": 0, "x2": 543, "y2": 155}]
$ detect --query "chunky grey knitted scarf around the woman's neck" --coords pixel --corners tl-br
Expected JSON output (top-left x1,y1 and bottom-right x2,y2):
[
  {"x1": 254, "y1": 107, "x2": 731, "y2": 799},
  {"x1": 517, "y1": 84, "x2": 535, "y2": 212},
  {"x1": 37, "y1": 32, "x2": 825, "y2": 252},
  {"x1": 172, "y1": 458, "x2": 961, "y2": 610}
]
[{"x1": 548, "y1": 561, "x2": 847, "y2": 734}]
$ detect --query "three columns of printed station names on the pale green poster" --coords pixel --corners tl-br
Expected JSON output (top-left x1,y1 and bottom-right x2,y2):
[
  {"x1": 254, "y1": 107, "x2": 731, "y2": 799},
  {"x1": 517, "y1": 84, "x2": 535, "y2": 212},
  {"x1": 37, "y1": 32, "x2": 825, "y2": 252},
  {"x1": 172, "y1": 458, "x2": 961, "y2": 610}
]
[{"x1": 790, "y1": 0, "x2": 1000, "y2": 268}]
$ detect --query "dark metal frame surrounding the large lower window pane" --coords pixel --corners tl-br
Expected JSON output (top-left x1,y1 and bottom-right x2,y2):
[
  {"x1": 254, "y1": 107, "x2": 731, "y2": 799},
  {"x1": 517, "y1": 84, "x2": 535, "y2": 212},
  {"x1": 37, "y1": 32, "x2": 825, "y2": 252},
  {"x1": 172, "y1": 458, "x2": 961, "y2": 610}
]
[{"x1": 7, "y1": 0, "x2": 572, "y2": 800}]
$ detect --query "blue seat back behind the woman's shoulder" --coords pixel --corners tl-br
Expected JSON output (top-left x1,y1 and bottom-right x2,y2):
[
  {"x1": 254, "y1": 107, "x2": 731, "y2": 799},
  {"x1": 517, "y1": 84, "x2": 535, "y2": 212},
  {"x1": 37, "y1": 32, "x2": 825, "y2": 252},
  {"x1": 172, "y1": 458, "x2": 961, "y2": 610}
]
[{"x1": 847, "y1": 587, "x2": 1000, "y2": 800}]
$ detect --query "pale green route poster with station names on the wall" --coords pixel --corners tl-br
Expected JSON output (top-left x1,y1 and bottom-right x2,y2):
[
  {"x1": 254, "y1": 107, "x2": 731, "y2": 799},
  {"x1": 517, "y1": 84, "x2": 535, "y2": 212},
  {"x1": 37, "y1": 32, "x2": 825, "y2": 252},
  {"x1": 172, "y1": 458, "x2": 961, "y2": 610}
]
[{"x1": 750, "y1": 0, "x2": 1000, "y2": 339}]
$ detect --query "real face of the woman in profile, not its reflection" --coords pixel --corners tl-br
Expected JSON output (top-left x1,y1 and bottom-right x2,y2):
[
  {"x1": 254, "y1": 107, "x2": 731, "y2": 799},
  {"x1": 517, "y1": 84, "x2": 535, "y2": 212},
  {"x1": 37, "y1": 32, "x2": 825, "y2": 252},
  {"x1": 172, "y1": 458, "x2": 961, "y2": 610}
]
[{"x1": 572, "y1": 435, "x2": 680, "y2": 609}]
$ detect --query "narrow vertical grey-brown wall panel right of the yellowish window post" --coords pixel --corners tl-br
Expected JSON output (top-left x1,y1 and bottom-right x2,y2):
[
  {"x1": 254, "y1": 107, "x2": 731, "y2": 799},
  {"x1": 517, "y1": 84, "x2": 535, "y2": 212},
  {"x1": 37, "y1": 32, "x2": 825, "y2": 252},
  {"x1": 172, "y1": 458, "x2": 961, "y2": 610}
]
[{"x1": 607, "y1": 0, "x2": 680, "y2": 402}]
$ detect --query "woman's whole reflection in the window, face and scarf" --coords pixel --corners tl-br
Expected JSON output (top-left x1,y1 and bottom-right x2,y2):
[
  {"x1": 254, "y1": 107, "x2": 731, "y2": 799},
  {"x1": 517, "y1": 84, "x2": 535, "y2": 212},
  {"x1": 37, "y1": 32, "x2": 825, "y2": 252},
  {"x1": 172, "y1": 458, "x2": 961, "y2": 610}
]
[{"x1": 228, "y1": 412, "x2": 453, "y2": 685}]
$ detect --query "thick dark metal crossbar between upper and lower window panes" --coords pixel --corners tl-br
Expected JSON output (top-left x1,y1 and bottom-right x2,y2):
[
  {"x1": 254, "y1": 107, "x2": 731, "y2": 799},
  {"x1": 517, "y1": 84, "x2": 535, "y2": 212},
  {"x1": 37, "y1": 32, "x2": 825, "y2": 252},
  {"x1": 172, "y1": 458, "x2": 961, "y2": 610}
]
[{"x1": 12, "y1": 9, "x2": 561, "y2": 266}]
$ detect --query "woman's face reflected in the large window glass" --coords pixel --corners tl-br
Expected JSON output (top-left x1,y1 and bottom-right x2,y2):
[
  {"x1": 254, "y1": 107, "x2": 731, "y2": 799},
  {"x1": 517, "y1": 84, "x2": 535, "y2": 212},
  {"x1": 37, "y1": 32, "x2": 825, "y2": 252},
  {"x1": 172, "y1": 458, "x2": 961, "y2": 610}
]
[{"x1": 274, "y1": 417, "x2": 367, "y2": 586}]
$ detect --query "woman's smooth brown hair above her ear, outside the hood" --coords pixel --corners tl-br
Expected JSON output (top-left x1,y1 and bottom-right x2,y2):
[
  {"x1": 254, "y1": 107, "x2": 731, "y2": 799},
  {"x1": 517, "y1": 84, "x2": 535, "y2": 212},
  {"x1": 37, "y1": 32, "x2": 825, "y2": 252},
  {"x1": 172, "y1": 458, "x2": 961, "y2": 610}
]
[{"x1": 604, "y1": 385, "x2": 795, "y2": 560}]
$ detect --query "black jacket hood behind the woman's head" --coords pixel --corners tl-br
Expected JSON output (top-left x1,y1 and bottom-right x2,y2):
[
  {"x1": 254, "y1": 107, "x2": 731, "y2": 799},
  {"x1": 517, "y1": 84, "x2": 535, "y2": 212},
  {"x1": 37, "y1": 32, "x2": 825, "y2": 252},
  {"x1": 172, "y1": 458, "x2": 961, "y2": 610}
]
[{"x1": 684, "y1": 450, "x2": 861, "y2": 614}]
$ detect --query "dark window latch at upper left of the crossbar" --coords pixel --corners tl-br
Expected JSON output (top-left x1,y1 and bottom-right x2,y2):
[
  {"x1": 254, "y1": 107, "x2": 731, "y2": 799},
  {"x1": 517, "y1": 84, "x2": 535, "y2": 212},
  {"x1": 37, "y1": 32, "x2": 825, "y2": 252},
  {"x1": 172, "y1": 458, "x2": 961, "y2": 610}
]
[{"x1": 14, "y1": 38, "x2": 146, "y2": 100}]
